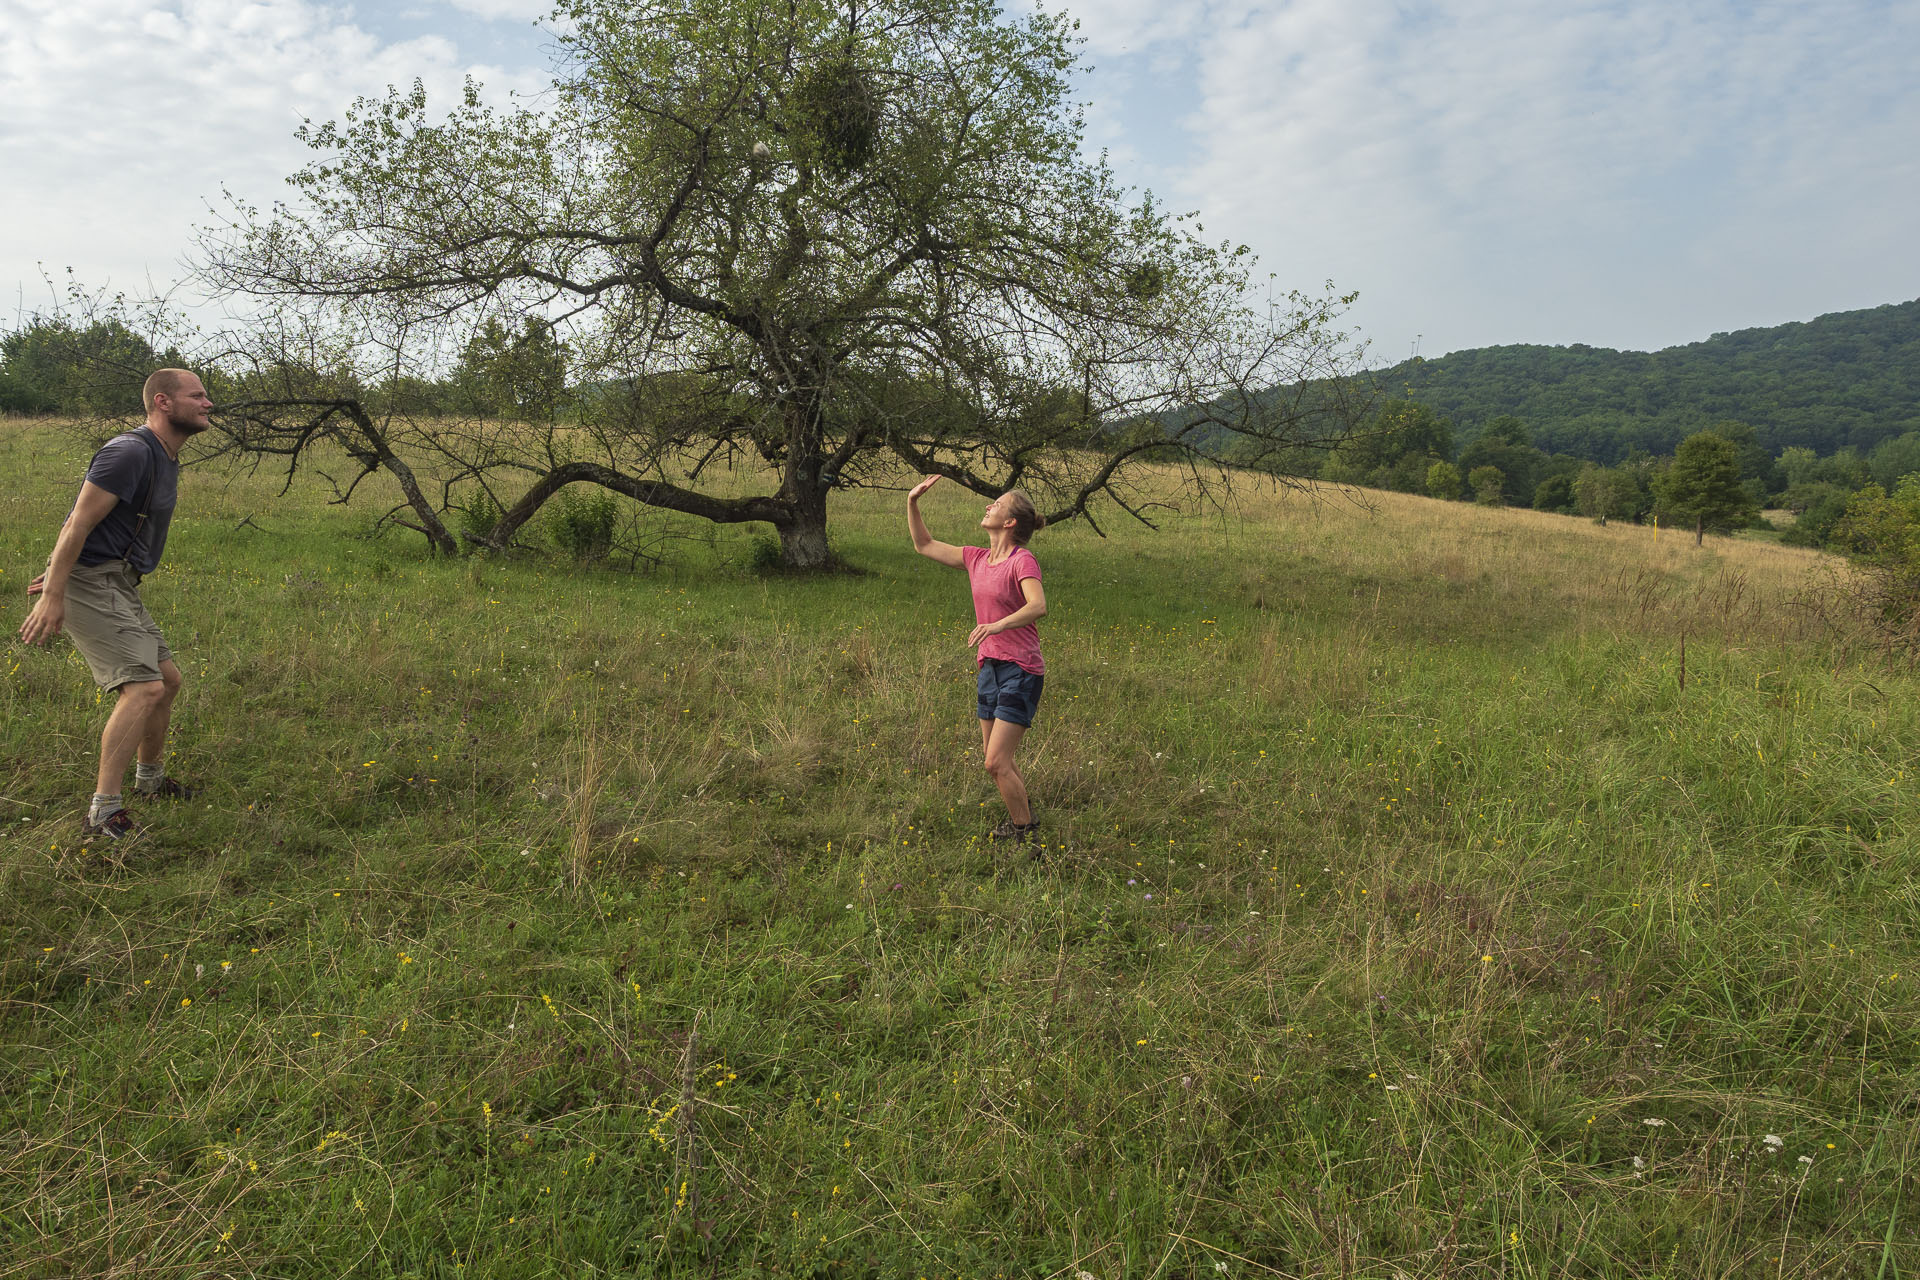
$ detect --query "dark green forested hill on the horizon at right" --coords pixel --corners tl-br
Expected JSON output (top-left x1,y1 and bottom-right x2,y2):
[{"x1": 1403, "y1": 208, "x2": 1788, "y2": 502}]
[{"x1": 1377, "y1": 301, "x2": 1920, "y2": 464}]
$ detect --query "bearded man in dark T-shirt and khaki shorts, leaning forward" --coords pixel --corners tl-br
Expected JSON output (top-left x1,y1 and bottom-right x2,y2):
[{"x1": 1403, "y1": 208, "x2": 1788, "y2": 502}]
[{"x1": 19, "y1": 368, "x2": 213, "y2": 841}]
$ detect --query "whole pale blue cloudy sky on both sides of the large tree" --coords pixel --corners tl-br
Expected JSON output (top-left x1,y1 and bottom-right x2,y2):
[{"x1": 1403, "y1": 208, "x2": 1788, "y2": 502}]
[{"x1": 0, "y1": 0, "x2": 1920, "y2": 365}]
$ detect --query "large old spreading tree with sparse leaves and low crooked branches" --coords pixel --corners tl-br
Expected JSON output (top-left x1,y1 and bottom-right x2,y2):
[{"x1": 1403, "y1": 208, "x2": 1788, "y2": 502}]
[{"x1": 204, "y1": 0, "x2": 1350, "y2": 568}]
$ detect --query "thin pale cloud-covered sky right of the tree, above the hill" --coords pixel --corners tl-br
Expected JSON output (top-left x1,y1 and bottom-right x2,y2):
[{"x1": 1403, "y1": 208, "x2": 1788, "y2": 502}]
[{"x1": 1071, "y1": 0, "x2": 1920, "y2": 357}]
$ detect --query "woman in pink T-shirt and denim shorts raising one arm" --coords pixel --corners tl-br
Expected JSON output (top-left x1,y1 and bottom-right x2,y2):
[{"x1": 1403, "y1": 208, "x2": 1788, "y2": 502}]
[{"x1": 906, "y1": 476, "x2": 1046, "y2": 846}]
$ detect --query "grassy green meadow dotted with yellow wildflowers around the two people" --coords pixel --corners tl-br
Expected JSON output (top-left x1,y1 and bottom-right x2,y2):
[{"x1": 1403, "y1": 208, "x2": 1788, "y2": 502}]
[{"x1": 0, "y1": 422, "x2": 1920, "y2": 1280}]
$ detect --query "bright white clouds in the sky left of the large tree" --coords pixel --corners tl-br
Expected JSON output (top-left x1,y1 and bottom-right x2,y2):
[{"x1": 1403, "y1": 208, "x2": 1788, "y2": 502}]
[{"x1": 0, "y1": 0, "x2": 545, "y2": 311}]
